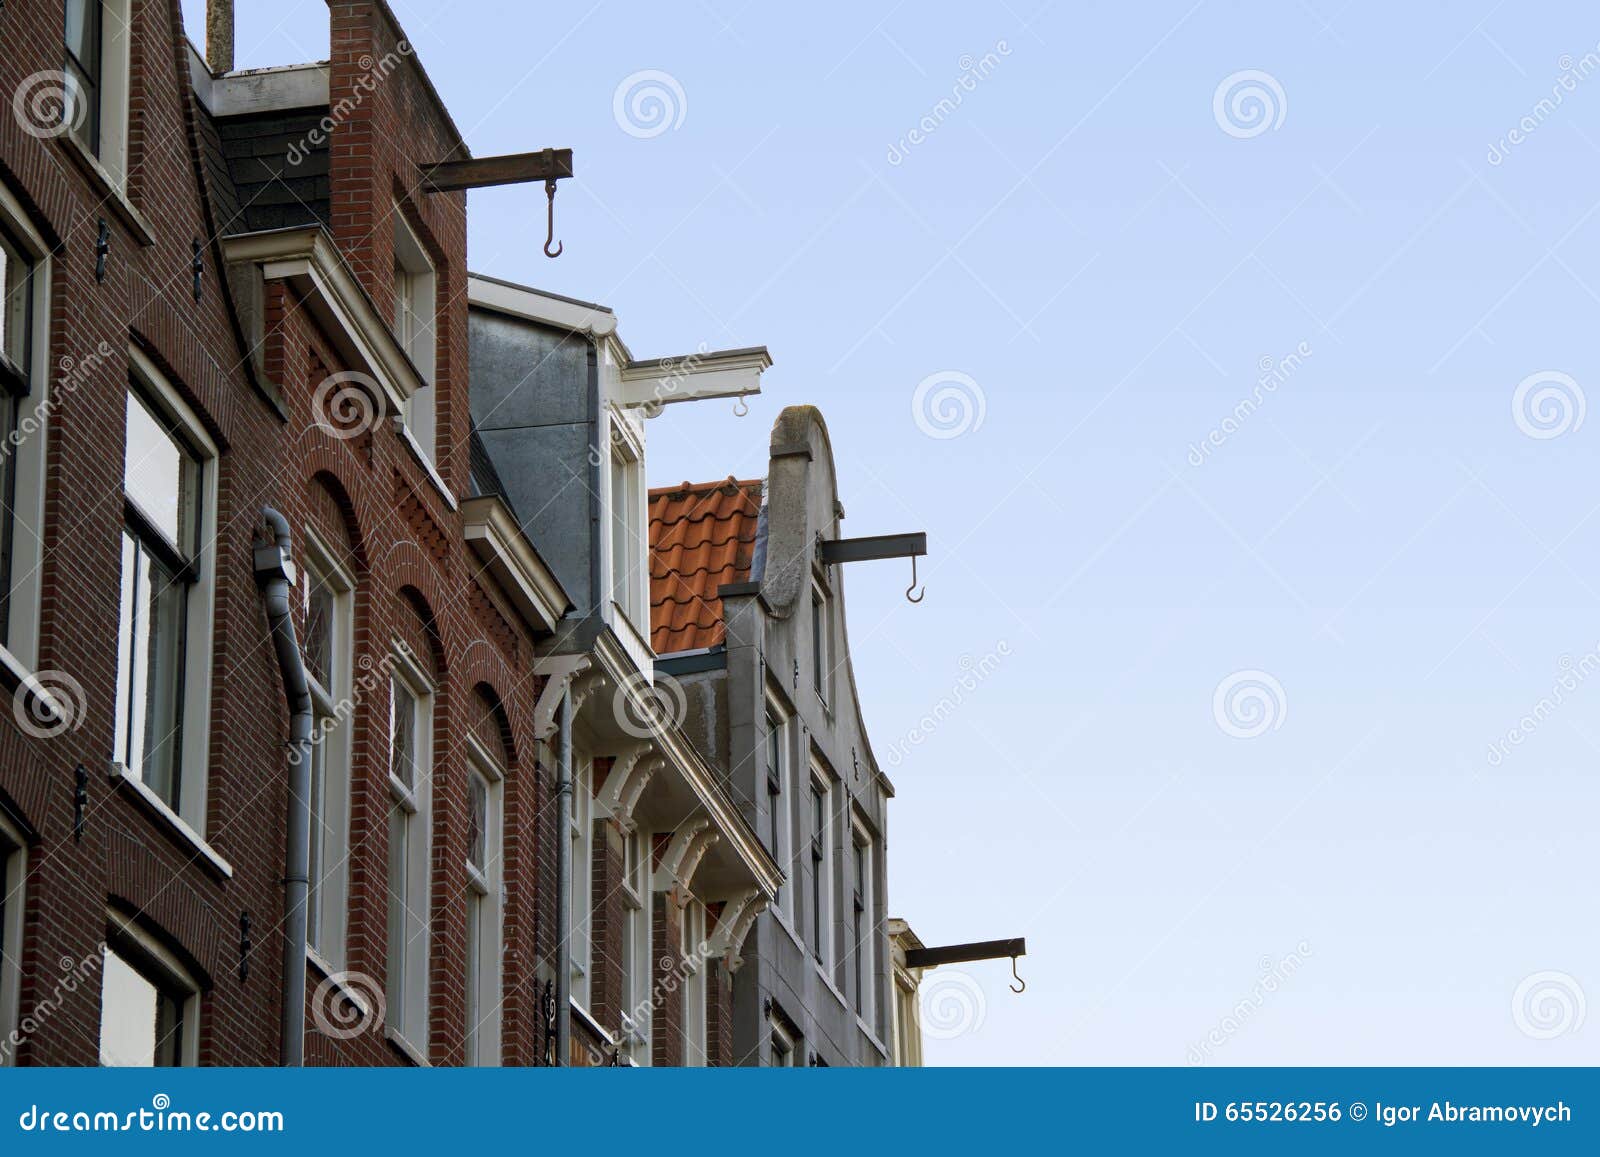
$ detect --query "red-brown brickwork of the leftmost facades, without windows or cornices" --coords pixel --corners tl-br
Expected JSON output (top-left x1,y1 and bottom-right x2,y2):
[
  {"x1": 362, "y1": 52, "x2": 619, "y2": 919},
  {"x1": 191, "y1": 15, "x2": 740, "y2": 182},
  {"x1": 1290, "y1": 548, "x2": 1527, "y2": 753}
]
[{"x1": 0, "y1": 0, "x2": 554, "y2": 1064}]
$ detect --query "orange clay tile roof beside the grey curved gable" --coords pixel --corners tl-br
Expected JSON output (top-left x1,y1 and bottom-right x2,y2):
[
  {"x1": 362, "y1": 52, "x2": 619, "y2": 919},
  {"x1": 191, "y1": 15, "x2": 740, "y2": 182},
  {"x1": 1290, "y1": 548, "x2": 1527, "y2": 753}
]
[{"x1": 650, "y1": 478, "x2": 763, "y2": 655}]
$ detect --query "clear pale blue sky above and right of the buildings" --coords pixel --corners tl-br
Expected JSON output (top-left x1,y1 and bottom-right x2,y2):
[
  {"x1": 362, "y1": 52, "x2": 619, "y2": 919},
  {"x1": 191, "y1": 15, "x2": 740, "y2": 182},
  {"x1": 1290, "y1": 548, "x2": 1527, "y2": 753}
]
[{"x1": 184, "y1": 0, "x2": 1600, "y2": 1064}]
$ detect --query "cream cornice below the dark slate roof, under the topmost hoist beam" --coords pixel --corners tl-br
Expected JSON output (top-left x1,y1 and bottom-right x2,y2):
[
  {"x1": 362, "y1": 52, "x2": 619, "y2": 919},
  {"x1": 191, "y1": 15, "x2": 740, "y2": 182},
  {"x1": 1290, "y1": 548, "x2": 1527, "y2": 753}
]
[{"x1": 222, "y1": 226, "x2": 426, "y2": 414}]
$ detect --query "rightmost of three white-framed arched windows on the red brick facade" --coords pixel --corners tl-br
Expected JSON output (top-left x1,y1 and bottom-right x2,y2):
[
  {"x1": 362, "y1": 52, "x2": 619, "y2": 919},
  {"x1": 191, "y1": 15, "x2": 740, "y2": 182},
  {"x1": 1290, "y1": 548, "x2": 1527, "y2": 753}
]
[{"x1": 467, "y1": 739, "x2": 506, "y2": 1067}]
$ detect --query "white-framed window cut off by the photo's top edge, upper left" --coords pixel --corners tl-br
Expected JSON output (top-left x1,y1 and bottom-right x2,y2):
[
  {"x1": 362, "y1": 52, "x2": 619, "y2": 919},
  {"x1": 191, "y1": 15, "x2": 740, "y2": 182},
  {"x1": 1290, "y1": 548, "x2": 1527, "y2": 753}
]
[{"x1": 61, "y1": 0, "x2": 130, "y2": 187}]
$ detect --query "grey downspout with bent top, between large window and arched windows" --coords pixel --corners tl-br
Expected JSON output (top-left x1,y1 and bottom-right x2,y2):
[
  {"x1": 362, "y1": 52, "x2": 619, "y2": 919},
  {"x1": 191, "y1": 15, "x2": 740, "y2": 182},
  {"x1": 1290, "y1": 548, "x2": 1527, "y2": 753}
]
[{"x1": 256, "y1": 506, "x2": 312, "y2": 1067}]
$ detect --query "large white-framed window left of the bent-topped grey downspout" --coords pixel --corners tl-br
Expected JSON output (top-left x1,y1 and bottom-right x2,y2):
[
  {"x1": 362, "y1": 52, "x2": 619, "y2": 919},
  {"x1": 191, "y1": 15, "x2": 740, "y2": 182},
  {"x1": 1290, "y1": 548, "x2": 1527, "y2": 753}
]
[{"x1": 112, "y1": 350, "x2": 218, "y2": 834}]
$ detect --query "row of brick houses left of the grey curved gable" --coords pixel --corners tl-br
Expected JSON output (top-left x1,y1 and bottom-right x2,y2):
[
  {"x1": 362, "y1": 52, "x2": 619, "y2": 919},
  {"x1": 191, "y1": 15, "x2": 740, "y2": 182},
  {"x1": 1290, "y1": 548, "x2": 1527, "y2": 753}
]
[{"x1": 0, "y1": 0, "x2": 796, "y2": 1064}]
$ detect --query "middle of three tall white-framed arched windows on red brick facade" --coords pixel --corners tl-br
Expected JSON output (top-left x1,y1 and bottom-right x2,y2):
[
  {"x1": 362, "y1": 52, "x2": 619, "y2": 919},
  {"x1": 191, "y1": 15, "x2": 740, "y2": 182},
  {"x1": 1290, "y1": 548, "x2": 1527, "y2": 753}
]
[{"x1": 386, "y1": 648, "x2": 434, "y2": 1055}]
